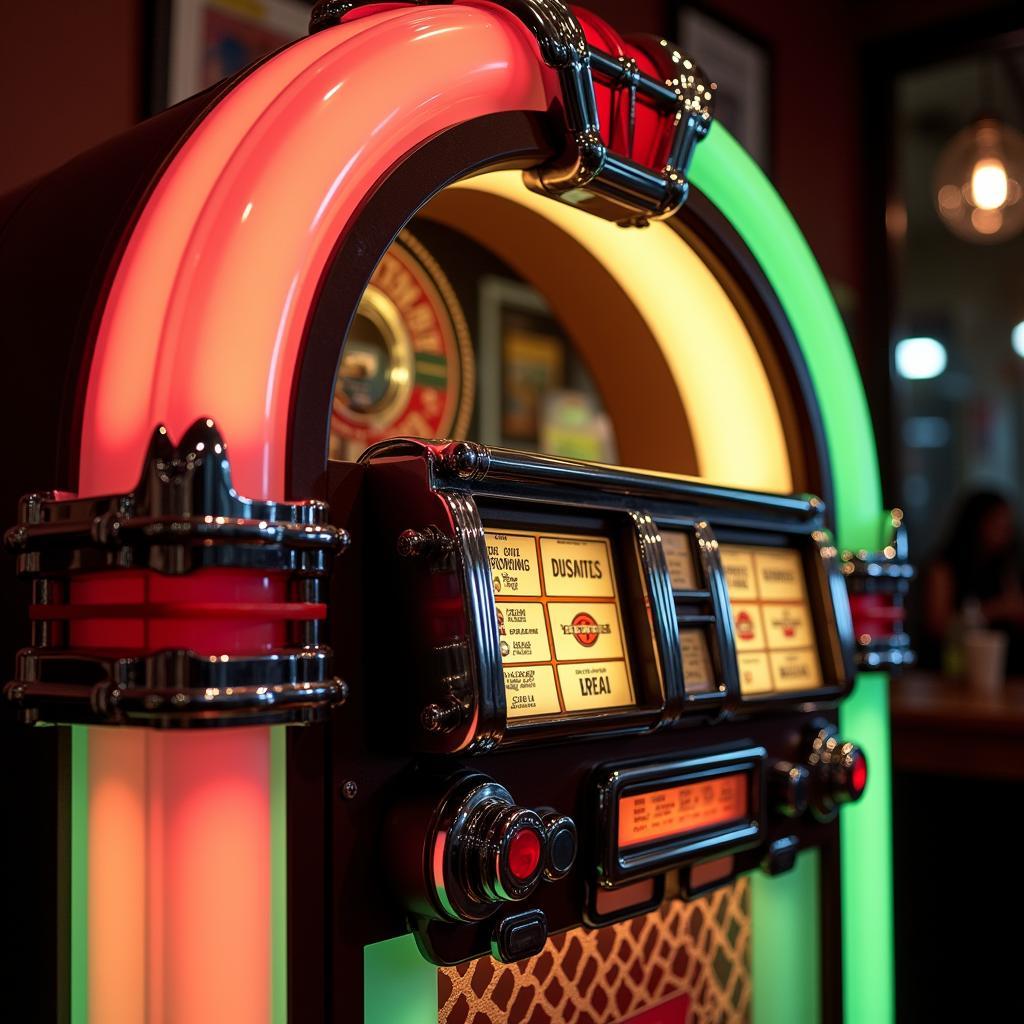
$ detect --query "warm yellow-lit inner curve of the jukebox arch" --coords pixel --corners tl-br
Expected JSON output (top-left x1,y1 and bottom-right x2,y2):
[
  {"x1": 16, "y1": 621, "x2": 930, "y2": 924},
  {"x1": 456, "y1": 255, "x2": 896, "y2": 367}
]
[{"x1": 331, "y1": 171, "x2": 800, "y2": 493}]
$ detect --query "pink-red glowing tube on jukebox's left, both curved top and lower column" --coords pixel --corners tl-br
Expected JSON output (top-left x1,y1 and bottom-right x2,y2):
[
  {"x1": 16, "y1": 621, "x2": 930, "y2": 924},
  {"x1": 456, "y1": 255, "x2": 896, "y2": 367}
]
[{"x1": 80, "y1": 3, "x2": 554, "y2": 1024}]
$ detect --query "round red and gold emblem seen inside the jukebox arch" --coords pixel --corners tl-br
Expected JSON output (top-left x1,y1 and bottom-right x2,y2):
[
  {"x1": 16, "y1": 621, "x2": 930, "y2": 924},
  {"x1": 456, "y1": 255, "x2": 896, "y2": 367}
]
[{"x1": 331, "y1": 231, "x2": 474, "y2": 459}]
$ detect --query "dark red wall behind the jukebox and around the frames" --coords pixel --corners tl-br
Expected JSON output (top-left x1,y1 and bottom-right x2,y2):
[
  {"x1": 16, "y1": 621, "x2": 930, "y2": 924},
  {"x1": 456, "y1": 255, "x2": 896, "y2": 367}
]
[{"x1": 0, "y1": 0, "x2": 1007, "y2": 409}]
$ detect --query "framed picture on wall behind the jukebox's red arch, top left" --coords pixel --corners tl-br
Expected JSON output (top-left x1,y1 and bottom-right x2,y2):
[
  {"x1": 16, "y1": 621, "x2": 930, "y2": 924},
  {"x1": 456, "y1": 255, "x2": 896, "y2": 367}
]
[{"x1": 143, "y1": 0, "x2": 310, "y2": 114}]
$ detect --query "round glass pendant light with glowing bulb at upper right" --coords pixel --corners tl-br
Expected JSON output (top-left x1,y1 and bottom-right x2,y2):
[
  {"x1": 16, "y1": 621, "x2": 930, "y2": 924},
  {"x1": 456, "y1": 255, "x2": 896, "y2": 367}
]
[{"x1": 935, "y1": 117, "x2": 1024, "y2": 244}]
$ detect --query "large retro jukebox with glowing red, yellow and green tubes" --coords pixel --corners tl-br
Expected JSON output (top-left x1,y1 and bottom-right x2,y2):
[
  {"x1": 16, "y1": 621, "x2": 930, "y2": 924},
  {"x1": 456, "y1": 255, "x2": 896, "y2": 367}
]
[{"x1": 0, "y1": 0, "x2": 910, "y2": 1024}]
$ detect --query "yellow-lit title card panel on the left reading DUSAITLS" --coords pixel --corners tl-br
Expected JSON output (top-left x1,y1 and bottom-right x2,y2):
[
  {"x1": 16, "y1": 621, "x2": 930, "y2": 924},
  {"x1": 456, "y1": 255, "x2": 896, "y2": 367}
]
[{"x1": 484, "y1": 529, "x2": 636, "y2": 719}]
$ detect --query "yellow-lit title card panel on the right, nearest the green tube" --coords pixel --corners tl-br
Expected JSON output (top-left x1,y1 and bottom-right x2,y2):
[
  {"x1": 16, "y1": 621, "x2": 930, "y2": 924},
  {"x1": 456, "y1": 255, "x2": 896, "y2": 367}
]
[{"x1": 719, "y1": 544, "x2": 822, "y2": 696}]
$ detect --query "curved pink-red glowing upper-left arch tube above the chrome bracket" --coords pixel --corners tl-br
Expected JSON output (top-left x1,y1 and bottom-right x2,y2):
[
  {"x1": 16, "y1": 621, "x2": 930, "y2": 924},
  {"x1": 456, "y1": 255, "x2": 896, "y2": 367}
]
[{"x1": 80, "y1": 4, "x2": 553, "y2": 498}]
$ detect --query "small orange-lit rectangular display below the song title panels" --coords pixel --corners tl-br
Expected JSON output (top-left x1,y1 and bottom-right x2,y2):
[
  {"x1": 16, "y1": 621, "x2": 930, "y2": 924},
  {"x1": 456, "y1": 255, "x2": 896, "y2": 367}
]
[{"x1": 618, "y1": 772, "x2": 750, "y2": 850}]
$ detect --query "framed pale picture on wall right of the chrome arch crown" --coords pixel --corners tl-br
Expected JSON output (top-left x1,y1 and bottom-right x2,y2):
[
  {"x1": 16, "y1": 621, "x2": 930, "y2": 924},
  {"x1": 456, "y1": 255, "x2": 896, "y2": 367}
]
[{"x1": 676, "y1": 6, "x2": 771, "y2": 172}]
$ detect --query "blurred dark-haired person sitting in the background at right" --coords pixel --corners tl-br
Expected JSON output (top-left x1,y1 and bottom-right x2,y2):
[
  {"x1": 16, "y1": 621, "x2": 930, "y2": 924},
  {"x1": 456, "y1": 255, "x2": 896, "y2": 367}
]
[{"x1": 921, "y1": 490, "x2": 1024, "y2": 675}]
